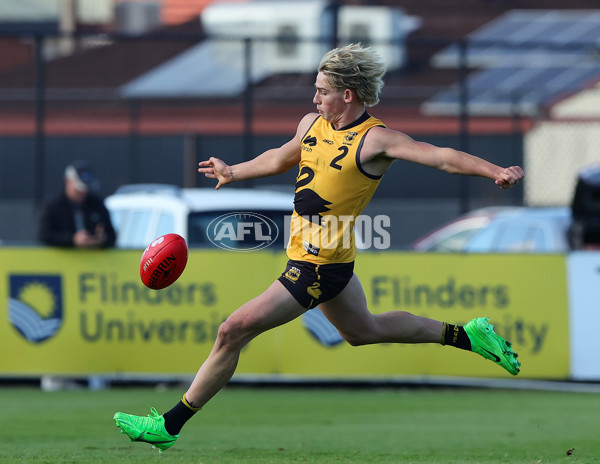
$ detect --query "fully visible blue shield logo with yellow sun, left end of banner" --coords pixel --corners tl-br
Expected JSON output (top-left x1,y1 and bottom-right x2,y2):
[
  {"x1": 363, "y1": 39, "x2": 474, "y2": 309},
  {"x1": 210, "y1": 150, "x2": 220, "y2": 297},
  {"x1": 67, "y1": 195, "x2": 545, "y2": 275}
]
[{"x1": 8, "y1": 274, "x2": 63, "y2": 343}]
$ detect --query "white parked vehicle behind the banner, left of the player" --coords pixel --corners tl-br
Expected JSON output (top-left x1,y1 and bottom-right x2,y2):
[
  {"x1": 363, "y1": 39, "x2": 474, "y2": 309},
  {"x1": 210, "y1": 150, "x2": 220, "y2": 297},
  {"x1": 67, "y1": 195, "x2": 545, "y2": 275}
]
[{"x1": 105, "y1": 184, "x2": 294, "y2": 251}]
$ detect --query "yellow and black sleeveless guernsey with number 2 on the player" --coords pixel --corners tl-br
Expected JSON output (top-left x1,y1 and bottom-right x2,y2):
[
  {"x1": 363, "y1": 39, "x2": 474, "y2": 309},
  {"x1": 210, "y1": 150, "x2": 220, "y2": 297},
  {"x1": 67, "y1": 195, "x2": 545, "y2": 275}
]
[{"x1": 287, "y1": 112, "x2": 385, "y2": 264}]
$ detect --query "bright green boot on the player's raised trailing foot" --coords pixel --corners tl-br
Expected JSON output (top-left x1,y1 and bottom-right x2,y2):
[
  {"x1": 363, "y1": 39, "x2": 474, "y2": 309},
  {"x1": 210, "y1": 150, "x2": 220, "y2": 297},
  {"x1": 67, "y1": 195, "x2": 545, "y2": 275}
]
[{"x1": 463, "y1": 317, "x2": 521, "y2": 375}]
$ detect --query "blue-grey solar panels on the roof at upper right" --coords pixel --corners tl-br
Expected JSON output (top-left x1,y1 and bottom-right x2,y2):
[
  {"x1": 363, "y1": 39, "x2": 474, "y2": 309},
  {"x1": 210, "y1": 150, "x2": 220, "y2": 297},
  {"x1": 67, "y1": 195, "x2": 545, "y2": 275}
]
[{"x1": 424, "y1": 10, "x2": 600, "y2": 115}]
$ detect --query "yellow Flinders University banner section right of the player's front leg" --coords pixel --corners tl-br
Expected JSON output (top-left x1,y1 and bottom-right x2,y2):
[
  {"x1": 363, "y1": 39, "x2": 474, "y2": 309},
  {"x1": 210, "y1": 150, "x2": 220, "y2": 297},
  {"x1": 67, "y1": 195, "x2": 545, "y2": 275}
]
[{"x1": 240, "y1": 252, "x2": 569, "y2": 379}]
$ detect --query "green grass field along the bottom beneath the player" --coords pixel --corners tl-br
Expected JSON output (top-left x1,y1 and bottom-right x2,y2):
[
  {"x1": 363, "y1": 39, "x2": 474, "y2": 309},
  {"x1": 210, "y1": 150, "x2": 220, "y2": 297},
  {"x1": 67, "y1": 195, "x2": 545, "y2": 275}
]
[{"x1": 0, "y1": 388, "x2": 600, "y2": 464}]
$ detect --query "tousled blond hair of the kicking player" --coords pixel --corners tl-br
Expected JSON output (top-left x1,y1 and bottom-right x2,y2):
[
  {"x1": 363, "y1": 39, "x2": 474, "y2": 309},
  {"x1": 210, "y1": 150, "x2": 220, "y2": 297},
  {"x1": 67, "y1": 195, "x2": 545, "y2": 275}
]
[{"x1": 319, "y1": 44, "x2": 385, "y2": 106}]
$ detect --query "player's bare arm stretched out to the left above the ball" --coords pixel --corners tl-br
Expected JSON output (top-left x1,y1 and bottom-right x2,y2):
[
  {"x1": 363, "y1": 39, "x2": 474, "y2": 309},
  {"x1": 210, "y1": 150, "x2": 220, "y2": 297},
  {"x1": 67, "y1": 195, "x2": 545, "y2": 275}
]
[{"x1": 198, "y1": 113, "x2": 317, "y2": 190}]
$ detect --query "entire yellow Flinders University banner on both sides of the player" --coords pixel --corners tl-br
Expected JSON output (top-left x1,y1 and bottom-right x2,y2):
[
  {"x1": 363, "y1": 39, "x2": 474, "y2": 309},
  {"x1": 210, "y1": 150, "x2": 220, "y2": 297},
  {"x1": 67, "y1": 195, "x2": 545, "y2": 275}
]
[{"x1": 0, "y1": 248, "x2": 569, "y2": 379}]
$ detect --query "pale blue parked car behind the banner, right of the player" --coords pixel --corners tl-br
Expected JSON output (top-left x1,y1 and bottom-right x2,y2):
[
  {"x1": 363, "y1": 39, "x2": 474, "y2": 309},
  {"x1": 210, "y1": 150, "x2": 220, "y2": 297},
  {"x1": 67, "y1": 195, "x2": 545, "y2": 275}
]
[{"x1": 411, "y1": 207, "x2": 572, "y2": 253}]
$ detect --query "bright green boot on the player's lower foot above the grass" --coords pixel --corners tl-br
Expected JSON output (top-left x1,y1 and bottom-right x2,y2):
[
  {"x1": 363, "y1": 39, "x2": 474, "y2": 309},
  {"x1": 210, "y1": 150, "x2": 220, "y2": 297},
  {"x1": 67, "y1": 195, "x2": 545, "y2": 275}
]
[{"x1": 113, "y1": 408, "x2": 179, "y2": 452}]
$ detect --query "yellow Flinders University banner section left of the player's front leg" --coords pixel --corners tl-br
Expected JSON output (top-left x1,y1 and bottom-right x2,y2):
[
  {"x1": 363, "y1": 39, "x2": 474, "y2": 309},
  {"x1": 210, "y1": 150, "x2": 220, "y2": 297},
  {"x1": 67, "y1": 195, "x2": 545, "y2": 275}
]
[{"x1": 0, "y1": 248, "x2": 275, "y2": 374}]
